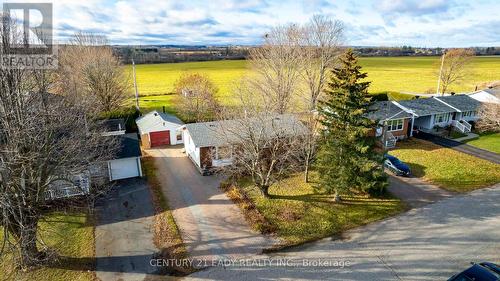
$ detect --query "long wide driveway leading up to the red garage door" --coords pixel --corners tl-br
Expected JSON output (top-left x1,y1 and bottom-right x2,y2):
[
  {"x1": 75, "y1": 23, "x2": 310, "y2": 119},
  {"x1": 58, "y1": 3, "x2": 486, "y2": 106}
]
[{"x1": 147, "y1": 146, "x2": 276, "y2": 265}]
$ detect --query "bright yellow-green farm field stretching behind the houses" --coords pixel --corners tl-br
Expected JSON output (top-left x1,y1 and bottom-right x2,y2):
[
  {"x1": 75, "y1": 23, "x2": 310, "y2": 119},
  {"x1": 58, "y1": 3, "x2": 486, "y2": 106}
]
[{"x1": 126, "y1": 57, "x2": 500, "y2": 112}]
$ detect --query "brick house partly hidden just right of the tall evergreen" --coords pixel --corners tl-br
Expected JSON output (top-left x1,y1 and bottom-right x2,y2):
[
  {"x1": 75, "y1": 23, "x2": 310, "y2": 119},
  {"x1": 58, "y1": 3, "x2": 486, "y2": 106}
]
[{"x1": 367, "y1": 101, "x2": 413, "y2": 148}]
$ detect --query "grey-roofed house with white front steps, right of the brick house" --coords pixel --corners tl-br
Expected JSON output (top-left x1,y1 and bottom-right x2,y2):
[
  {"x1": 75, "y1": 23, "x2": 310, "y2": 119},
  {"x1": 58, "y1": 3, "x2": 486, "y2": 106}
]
[{"x1": 397, "y1": 95, "x2": 481, "y2": 133}]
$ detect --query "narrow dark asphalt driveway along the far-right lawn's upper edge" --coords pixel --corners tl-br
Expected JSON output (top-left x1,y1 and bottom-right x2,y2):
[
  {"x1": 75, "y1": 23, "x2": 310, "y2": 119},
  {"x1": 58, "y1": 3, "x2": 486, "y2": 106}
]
[{"x1": 416, "y1": 132, "x2": 500, "y2": 164}]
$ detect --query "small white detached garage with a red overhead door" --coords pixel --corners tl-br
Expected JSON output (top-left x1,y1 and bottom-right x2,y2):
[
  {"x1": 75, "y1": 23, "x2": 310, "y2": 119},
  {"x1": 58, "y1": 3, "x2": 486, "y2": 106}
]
[{"x1": 135, "y1": 110, "x2": 184, "y2": 148}]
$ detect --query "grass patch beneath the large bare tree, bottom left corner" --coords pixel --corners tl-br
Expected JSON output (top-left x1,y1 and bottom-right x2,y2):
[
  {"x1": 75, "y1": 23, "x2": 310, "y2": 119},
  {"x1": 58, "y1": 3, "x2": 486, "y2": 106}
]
[{"x1": 0, "y1": 212, "x2": 96, "y2": 281}]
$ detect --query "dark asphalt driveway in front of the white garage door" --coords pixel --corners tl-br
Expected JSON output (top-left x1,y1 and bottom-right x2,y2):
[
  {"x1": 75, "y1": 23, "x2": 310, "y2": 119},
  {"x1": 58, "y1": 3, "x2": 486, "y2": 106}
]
[{"x1": 95, "y1": 179, "x2": 157, "y2": 281}]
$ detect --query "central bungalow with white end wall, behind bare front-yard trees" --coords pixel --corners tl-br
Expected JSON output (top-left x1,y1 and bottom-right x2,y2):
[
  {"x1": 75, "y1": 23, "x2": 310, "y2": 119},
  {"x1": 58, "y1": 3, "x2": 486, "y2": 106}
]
[{"x1": 181, "y1": 114, "x2": 307, "y2": 175}]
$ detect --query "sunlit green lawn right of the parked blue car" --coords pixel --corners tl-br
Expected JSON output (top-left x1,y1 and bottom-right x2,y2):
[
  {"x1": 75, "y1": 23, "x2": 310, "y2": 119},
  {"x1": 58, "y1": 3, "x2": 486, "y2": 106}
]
[{"x1": 390, "y1": 139, "x2": 500, "y2": 192}]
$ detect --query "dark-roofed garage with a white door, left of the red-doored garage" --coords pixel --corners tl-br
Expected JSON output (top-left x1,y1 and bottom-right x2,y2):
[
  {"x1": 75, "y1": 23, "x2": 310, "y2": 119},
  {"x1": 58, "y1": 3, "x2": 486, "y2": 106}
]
[{"x1": 108, "y1": 134, "x2": 142, "y2": 181}]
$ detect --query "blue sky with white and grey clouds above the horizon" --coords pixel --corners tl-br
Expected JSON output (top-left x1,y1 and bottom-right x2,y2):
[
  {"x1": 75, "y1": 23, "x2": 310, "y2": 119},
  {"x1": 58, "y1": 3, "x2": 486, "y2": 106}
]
[{"x1": 3, "y1": 0, "x2": 500, "y2": 47}]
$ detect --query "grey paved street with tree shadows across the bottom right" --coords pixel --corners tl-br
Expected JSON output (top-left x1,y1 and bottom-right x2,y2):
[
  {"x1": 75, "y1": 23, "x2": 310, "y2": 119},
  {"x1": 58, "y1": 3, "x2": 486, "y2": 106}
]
[{"x1": 189, "y1": 185, "x2": 500, "y2": 281}]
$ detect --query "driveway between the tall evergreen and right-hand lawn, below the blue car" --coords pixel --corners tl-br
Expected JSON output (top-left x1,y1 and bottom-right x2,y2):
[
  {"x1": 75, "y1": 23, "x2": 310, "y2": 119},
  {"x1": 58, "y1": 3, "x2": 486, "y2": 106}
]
[{"x1": 388, "y1": 172, "x2": 455, "y2": 208}]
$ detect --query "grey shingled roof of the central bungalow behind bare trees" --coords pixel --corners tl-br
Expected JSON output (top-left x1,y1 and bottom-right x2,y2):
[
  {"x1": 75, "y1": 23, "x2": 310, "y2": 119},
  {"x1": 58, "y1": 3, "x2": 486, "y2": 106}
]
[{"x1": 186, "y1": 114, "x2": 307, "y2": 147}]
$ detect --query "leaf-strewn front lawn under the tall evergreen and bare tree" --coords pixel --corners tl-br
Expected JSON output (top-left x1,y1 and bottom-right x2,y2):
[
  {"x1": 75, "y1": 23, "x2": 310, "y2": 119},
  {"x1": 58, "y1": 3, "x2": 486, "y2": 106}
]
[{"x1": 232, "y1": 172, "x2": 404, "y2": 246}]
